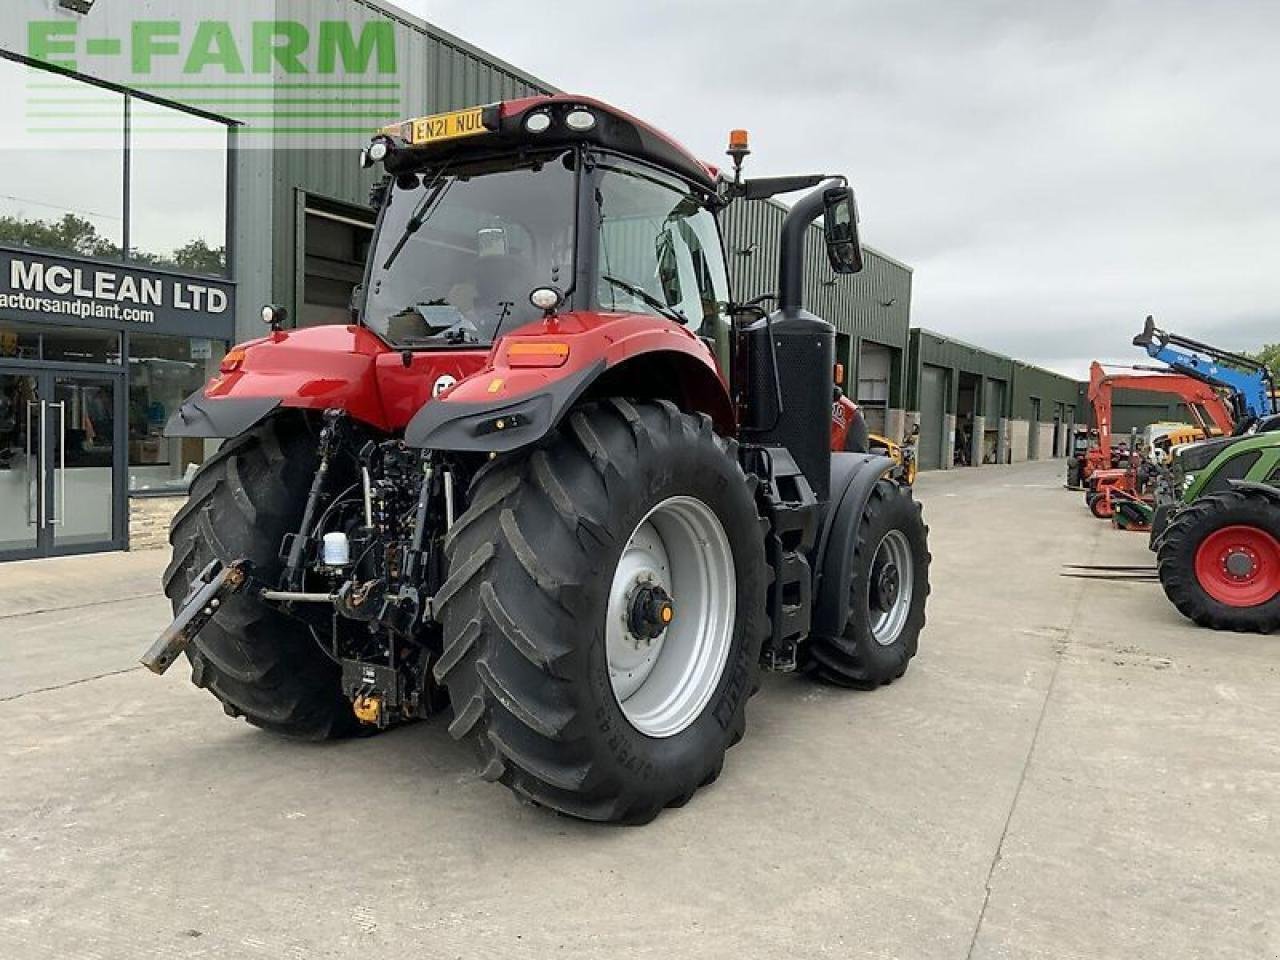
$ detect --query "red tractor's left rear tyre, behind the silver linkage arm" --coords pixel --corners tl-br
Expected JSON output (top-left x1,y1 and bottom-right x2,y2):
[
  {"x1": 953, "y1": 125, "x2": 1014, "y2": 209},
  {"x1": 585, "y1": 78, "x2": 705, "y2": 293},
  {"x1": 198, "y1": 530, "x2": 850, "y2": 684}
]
[{"x1": 164, "y1": 415, "x2": 360, "y2": 740}]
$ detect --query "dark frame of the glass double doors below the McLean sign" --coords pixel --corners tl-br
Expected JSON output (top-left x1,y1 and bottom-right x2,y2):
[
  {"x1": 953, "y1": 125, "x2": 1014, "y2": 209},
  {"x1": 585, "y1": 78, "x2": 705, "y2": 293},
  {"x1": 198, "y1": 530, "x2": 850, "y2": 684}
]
[{"x1": 0, "y1": 358, "x2": 129, "y2": 562}]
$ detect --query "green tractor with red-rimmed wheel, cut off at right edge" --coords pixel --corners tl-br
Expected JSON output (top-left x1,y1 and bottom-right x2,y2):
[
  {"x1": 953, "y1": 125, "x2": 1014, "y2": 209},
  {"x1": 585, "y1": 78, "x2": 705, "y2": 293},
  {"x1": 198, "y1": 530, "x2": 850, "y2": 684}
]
[{"x1": 1151, "y1": 435, "x2": 1280, "y2": 634}]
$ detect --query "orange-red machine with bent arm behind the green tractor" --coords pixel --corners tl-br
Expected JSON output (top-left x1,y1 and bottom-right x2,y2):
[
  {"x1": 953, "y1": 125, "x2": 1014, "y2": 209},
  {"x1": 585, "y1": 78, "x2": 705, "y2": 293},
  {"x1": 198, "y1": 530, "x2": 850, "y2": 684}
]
[{"x1": 1071, "y1": 361, "x2": 1234, "y2": 518}]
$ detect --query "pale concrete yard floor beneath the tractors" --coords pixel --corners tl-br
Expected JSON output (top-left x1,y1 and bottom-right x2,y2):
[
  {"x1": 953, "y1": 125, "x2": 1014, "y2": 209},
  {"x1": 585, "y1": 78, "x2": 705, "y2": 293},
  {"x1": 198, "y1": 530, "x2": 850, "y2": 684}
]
[{"x1": 0, "y1": 461, "x2": 1280, "y2": 960}]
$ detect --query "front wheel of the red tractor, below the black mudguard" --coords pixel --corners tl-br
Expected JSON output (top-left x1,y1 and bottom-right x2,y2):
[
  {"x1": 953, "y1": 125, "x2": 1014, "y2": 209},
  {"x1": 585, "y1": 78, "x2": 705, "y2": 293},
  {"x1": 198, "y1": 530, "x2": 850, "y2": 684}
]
[{"x1": 806, "y1": 480, "x2": 931, "y2": 690}]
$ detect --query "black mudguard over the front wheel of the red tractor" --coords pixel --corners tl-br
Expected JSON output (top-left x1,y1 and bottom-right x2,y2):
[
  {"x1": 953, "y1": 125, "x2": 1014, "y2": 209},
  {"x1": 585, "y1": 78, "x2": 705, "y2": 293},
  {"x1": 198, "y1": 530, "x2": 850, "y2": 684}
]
[{"x1": 809, "y1": 453, "x2": 893, "y2": 647}]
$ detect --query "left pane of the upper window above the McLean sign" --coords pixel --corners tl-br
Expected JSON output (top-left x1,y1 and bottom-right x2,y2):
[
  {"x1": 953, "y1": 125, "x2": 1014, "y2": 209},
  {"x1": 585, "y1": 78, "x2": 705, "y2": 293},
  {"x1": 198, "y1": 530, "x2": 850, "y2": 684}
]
[{"x1": 0, "y1": 59, "x2": 124, "y2": 259}]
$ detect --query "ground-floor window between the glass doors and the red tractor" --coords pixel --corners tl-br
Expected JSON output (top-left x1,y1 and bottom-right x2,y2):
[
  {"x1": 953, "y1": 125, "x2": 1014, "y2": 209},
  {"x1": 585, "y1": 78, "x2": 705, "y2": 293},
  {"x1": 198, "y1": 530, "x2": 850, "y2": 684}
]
[{"x1": 129, "y1": 334, "x2": 227, "y2": 493}]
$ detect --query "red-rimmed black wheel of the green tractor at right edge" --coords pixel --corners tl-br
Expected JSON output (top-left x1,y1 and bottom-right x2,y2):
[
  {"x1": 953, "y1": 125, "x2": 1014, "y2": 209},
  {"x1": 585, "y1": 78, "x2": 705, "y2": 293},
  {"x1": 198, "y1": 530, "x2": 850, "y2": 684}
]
[{"x1": 1156, "y1": 490, "x2": 1280, "y2": 634}]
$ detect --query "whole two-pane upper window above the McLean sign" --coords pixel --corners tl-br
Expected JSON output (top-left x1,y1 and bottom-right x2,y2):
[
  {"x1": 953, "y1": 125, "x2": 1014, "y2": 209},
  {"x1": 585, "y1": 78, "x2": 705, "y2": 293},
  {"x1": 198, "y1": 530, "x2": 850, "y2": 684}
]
[{"x1": 0, "y1": 58, "x2": 230, "y2": 276}]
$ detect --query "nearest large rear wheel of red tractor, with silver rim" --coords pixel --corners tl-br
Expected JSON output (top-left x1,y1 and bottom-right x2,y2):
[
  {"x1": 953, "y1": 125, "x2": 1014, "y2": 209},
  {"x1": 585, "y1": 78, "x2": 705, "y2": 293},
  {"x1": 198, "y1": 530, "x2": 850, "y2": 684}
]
[{"x1": 435, "y1": 399, "x2": 767, "y2": 823}]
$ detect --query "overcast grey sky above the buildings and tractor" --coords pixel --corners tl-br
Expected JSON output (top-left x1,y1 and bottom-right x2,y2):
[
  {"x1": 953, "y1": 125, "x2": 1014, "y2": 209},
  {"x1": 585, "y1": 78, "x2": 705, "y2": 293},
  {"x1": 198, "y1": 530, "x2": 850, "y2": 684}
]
[{"x1": 399, "y1": 0, "x2": 1280, "y2": 376}]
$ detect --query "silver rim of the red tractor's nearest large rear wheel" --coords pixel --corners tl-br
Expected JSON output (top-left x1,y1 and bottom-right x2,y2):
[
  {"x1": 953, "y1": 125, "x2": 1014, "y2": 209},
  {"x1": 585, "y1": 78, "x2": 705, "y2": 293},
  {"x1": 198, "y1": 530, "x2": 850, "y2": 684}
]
[{"x1": 604, "y1": 497, "x2": 737, "y2": 737}]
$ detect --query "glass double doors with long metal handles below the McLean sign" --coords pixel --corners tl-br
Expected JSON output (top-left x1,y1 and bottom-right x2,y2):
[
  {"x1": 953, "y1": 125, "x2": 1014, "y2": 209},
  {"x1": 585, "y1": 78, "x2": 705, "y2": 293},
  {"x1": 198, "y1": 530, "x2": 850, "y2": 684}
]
[{"x1": 0, "y1": 370, "x2": 123, "y2": 559}]
